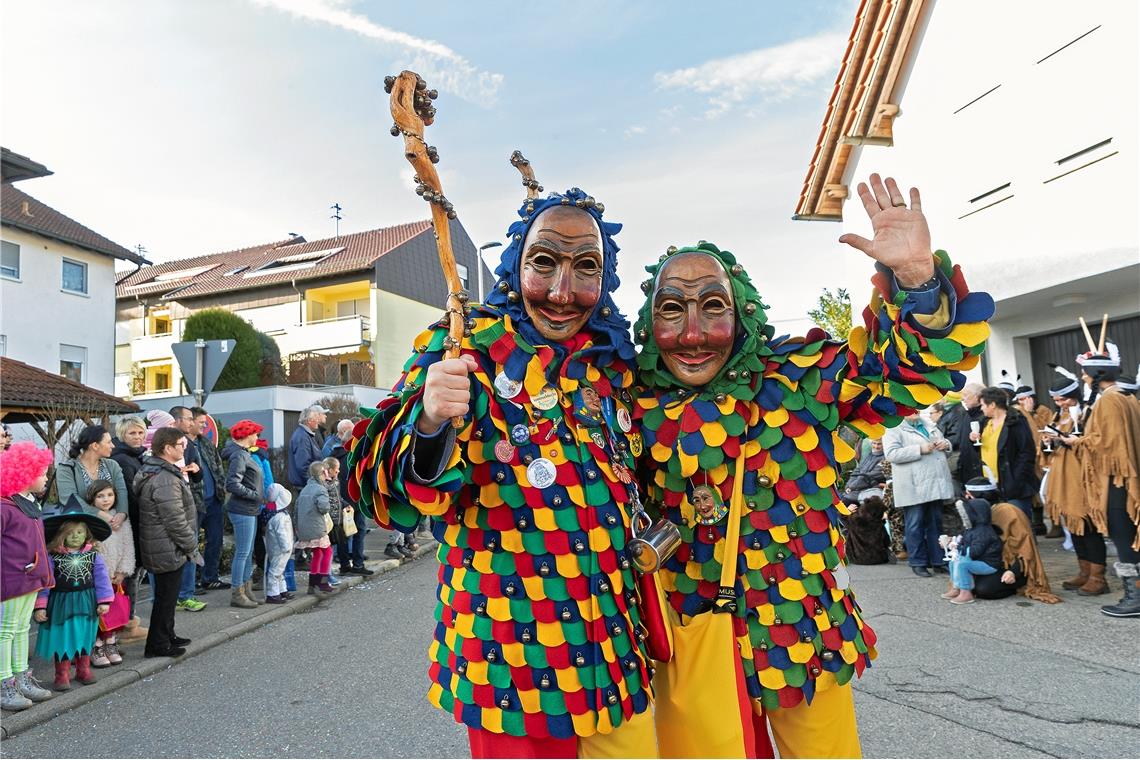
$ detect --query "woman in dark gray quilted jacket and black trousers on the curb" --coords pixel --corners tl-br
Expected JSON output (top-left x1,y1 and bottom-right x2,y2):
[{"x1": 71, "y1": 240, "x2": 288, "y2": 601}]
[{"x1": 135, "y1": 427, "x2": 198, "y2": 657}]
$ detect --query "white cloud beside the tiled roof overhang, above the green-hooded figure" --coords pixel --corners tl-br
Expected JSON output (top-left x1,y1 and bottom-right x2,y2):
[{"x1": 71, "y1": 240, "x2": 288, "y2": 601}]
[{"x1": 653, "y1": 32, "x2": 847, "y2": 116}]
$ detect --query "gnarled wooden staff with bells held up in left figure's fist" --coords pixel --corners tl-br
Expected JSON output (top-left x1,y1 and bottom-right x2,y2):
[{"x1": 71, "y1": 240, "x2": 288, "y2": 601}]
[{"x1": 384, "y1": 71, "x2": 470, "y2": 427}]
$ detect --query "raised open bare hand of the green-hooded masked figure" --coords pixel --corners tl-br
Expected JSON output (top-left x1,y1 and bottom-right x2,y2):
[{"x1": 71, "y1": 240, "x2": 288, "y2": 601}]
[{"x1": 839, "y1": 174, "x2": 934, "y2": 288}]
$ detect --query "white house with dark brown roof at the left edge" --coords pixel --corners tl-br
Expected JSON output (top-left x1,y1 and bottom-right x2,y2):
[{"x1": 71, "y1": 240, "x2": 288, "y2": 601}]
[{"x1": 0, "y1": 148, "x2": 149, "y2": 392}]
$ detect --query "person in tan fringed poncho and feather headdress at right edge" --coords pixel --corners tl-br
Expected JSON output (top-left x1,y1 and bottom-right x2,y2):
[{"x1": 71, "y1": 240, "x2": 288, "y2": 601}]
[{"x1": 1060, "y1": 340, "x2": 1140, "y2": 618}]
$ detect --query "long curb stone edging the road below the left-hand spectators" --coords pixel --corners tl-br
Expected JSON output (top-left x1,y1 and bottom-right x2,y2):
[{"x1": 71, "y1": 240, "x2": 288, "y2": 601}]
[{"x1": 0, "y1": 540, "x2": 439, "y2": 739}]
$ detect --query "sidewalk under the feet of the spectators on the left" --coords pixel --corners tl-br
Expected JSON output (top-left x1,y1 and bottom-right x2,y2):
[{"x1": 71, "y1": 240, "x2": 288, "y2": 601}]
[{"x1": 0, "y1": 528, "x2": 438, "y2": 738}]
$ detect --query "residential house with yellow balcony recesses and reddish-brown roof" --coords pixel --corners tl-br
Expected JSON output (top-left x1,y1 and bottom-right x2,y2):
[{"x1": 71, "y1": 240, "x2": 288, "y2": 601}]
[{"x1": 115, "y1": 220, "x2": 490, "y2": 399}]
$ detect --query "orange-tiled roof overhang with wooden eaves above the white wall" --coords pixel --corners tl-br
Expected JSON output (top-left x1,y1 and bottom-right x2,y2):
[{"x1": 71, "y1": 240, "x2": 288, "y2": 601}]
[{"x1": 792, "y1": 0, "x2": 933, "y2": 221}]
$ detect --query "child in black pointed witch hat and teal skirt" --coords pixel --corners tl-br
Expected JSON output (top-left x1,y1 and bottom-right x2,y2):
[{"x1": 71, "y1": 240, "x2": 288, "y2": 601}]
[{"x1": 35, "y1": 496, "x2": 115, "y2": 692}]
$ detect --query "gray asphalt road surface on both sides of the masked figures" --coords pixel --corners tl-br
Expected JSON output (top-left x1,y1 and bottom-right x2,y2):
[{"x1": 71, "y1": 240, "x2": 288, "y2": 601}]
[{"x1": 3, "y1": 549, "x2": 1140, "y2": 758}]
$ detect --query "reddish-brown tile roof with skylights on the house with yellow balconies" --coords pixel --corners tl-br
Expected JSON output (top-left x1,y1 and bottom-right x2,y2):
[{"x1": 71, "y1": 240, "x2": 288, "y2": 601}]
[{"x1": 115, "y1": 219, "x2": 432, "y2": 300}]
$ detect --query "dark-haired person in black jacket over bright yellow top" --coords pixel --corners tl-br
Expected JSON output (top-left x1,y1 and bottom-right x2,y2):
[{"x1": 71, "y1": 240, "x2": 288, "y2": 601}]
[{"x1": 970, "y1": 387, "x2": 1040, "y2": 522}]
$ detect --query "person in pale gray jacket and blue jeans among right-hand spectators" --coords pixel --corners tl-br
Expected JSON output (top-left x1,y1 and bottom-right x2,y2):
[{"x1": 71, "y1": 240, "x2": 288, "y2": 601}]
[{"x1": 882, "y1": 412, "x2": 954, "y2": 578}]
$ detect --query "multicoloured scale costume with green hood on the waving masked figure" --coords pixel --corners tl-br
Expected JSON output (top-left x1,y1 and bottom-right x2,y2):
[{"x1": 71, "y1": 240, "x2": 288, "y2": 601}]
[{"x1": 635, "y1": 243, "x2": 993, "y2": 709}]
